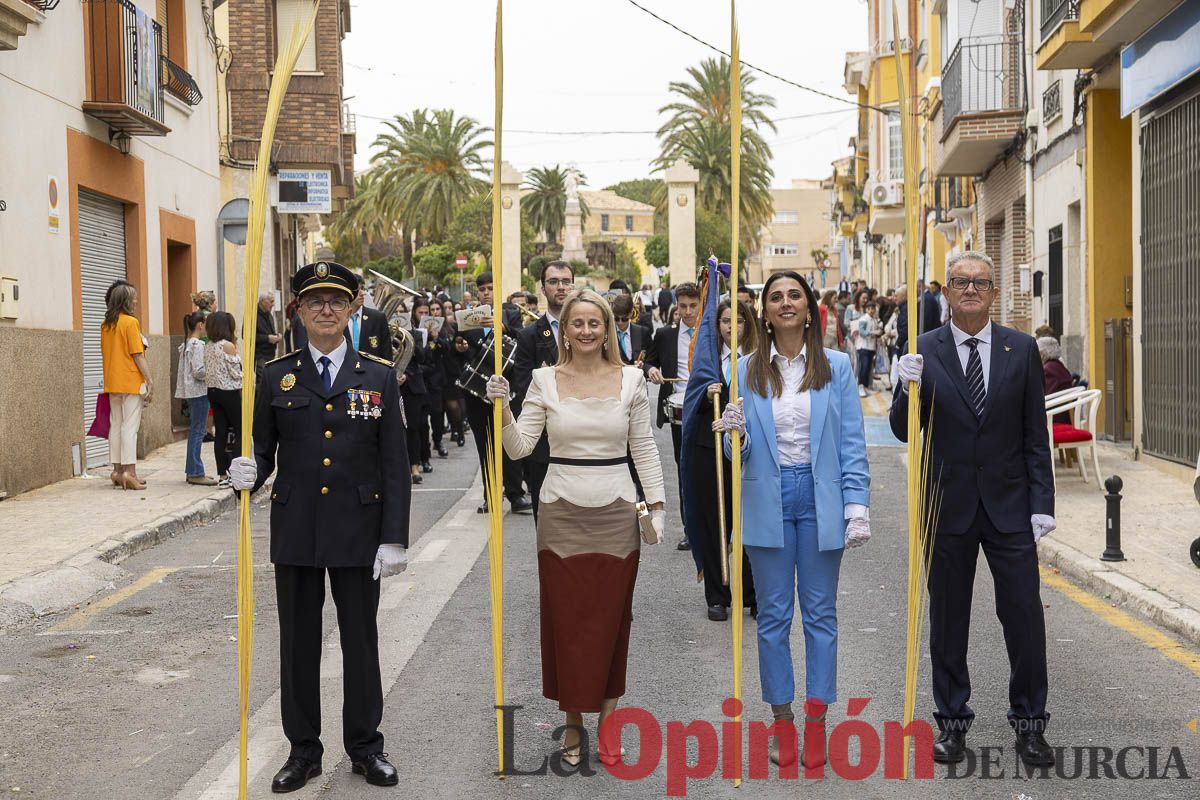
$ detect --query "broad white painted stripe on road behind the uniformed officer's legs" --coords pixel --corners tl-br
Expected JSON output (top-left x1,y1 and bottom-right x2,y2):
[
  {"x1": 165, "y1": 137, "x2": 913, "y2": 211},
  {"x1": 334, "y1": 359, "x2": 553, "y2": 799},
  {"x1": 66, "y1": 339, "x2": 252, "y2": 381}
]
[{"x1": 175, "y1": 479, "x2": 487, "y2": 800}]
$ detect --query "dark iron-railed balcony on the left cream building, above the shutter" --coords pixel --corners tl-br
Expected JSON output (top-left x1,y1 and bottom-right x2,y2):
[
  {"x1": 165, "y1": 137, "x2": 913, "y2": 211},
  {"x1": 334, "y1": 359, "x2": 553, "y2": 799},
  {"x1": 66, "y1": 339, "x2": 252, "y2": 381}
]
[{"x1": 83, "y1": 0, "x2": 169, "y2": 136}]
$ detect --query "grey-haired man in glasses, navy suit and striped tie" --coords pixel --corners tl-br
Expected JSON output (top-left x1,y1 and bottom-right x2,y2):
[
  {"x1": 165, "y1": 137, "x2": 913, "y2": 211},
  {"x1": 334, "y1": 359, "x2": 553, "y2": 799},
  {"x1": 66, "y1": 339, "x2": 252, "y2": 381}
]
[{"x1": 890, "y1": 252, "x2": 1055, "y2": 766}]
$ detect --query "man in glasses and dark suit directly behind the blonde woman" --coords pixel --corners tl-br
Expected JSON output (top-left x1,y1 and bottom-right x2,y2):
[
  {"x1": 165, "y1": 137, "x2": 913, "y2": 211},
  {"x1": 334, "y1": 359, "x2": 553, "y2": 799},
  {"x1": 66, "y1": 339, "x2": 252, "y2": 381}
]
[{"x1": 511, "y1": 261, "x2": 575, "y2": 521}]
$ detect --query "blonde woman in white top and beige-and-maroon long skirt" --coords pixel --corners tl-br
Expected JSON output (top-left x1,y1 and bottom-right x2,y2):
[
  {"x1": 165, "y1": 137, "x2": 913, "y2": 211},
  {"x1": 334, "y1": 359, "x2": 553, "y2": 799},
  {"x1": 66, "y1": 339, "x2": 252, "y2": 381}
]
[{"x1": 487, "y1": 289, "x2": 666, "y2": 765}]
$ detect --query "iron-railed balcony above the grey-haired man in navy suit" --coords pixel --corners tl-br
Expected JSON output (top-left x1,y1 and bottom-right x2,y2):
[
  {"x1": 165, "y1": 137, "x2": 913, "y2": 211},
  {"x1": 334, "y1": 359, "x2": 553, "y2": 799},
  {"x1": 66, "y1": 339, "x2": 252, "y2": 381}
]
[{"x1": 935, "y1": 36, "x2": 1026, "y2": 176}]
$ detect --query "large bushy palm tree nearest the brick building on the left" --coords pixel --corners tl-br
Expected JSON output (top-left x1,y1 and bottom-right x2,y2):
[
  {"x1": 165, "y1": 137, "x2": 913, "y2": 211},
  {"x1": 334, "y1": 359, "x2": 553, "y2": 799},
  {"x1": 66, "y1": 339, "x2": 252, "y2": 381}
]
[{"x1": 371, "y1": 109, "x2": 492, "y2": 248}]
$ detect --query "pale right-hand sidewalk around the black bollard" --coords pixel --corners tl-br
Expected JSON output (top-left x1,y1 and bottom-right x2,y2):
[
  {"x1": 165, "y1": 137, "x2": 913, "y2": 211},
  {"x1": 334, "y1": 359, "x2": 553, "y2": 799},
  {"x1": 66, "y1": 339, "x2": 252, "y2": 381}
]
[{"x1": 862, "y1": 392, "x2": 1200, "y2": 644}]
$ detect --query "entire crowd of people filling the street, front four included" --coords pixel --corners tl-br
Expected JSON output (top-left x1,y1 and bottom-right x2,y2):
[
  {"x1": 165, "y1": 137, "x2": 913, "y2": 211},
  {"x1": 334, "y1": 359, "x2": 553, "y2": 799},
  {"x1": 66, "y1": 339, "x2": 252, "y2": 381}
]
[{"x1": 93, "y1": 253, "x2": 1061, "y2": 792}]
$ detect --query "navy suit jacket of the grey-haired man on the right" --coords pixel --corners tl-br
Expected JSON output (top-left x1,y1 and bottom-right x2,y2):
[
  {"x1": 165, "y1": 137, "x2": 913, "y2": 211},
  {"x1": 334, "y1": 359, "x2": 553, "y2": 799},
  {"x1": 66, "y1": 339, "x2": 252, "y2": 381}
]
[{"x1": 889, "y1": 323, "x2": 1054, "y2": 536}]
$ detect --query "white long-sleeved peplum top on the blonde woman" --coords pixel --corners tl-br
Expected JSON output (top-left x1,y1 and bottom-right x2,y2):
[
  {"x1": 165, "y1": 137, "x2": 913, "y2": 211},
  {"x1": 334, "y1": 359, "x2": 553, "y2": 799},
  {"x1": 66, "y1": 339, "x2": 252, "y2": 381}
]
[{"x1": 502, "y1": 367, "x2": 666, "y2": 509}]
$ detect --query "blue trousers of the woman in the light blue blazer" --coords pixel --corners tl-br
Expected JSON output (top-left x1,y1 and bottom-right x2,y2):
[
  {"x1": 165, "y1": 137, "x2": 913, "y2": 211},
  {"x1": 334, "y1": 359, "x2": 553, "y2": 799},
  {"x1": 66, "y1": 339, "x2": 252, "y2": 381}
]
[{"x1": 745, "y1": 464, "x2": 842, "y2": 705}]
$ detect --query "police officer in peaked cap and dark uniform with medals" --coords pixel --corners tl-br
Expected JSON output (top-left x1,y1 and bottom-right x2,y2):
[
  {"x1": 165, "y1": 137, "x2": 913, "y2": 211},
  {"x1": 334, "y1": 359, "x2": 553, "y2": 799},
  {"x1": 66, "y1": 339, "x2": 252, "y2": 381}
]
[{"x1": 229, "y1": 261, "x2": 412, "y2": 792}]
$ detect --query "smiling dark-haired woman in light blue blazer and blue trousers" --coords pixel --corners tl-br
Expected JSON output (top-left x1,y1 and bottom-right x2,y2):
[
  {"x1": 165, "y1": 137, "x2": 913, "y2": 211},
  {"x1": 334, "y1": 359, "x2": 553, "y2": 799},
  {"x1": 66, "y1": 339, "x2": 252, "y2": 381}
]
[{"x1": 713, "y1": 271, "x2": 871, "y2": 766}]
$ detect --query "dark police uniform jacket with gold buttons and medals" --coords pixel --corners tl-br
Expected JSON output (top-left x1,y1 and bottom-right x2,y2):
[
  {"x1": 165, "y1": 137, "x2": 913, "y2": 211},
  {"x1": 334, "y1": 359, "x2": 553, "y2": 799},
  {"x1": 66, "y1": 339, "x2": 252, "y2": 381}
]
[{"x1": 254, "y1": 348, "x2": 412, "y2": 567}]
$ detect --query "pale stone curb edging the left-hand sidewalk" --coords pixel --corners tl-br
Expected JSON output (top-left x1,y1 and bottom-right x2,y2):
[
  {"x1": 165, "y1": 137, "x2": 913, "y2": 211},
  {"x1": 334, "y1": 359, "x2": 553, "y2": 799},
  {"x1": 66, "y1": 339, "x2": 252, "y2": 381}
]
[{"x1": 0, "y1": 476, "x2": 274, "y2": 632}]
